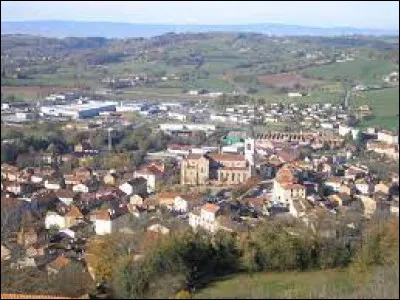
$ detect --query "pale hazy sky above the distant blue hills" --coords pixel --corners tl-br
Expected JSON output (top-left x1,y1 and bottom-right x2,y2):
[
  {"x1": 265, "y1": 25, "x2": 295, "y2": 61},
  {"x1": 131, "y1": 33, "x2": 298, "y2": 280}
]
[{"x1": 1, "y1": 0, "x2": 399, "y2": 29}]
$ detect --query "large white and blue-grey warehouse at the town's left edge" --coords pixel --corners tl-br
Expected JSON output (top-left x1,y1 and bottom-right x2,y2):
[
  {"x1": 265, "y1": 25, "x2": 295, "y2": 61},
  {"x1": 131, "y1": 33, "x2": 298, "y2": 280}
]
[{"x1": 40, "y1": 101, "x2": 117, "y2": 119}]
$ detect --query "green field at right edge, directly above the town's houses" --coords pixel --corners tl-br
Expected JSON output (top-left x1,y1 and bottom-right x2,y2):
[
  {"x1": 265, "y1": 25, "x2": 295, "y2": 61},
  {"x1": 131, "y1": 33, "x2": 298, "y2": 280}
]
[{"x1": 350, "y1": 87, "x2": 399, "y2": 130}]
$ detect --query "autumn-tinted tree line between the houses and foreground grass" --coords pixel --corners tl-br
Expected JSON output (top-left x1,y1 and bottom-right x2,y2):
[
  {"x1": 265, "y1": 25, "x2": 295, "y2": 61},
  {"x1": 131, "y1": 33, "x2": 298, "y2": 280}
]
[{"x1": 87, "y1": 214, "x2": 398, "y2": 299}]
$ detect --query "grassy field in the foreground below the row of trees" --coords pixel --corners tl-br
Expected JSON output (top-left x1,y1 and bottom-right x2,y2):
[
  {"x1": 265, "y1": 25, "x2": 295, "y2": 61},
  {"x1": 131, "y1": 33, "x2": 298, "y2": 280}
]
[{"x1": 194, "y1": 266, "x2": 399, "y2": 299}]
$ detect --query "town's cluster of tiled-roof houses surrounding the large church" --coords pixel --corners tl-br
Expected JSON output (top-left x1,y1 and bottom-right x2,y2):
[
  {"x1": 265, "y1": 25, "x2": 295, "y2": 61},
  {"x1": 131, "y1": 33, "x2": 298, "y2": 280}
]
[{"x1": 1, "y1": 95, "x2": 399, "y2": 290}]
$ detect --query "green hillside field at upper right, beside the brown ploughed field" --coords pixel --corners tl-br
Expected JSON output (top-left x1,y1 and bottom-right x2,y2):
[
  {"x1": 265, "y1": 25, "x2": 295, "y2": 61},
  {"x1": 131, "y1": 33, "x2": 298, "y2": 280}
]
[{"x1": 303, "y1": 59, "x2": 398, "y2": 84}]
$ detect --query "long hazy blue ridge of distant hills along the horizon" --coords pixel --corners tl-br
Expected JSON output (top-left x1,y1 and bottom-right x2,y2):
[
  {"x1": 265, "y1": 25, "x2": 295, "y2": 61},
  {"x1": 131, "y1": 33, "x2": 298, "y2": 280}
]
[{"x1": 1, "y1": 21, "x2": 399, "y2": 38}]
